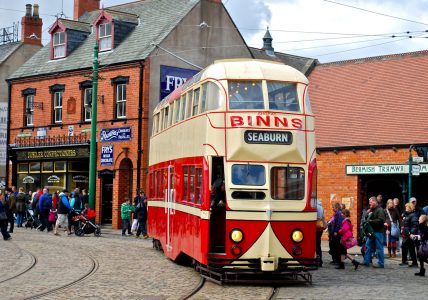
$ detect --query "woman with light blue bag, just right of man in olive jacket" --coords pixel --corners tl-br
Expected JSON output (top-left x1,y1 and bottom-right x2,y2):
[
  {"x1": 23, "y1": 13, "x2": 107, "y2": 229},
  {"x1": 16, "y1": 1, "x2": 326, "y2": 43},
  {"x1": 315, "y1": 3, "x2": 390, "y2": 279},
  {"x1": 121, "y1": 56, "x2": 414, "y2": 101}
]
[{"x1": 385, "y1": 199, "x2": 400, "y2": 257}]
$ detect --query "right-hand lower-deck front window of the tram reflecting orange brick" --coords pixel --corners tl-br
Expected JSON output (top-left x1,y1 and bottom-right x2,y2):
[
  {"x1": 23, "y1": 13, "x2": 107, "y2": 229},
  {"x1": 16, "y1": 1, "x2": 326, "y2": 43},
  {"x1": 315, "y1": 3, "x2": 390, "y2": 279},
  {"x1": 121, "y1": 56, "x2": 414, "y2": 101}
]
[{"x1": 270, "y1": 167, "x2": 305, "y2": 200}]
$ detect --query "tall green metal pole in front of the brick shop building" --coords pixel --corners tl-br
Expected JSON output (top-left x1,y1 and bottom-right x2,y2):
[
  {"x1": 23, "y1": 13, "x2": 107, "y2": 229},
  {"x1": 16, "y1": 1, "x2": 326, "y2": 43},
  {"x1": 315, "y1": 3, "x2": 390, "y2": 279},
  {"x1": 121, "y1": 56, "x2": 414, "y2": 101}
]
[{"x1": 88, "y1": 42, "x2": 98, "y2": 209}]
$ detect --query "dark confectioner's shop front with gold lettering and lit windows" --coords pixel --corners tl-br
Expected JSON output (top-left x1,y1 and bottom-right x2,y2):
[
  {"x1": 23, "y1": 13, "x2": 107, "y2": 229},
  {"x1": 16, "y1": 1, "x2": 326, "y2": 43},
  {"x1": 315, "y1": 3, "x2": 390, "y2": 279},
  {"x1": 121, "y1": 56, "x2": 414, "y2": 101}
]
[{"x1": 12, "y1": 146, "x2": 89, "y2": 192}]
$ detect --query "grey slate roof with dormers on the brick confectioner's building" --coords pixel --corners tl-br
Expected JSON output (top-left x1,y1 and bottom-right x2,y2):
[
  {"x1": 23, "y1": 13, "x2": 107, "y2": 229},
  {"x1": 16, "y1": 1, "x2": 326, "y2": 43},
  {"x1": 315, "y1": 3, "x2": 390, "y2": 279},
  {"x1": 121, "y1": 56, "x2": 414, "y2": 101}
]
[{"x1": 10, "y1": 0, "x2": 200, "y2": 79}]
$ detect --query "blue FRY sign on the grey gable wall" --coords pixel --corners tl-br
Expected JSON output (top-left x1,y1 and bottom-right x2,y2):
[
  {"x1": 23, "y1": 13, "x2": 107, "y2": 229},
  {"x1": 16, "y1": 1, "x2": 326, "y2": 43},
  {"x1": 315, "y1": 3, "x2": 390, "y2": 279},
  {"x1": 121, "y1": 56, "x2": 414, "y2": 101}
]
[{"x1": 159, "y1": 66, "x2": 198, "y2": 101}]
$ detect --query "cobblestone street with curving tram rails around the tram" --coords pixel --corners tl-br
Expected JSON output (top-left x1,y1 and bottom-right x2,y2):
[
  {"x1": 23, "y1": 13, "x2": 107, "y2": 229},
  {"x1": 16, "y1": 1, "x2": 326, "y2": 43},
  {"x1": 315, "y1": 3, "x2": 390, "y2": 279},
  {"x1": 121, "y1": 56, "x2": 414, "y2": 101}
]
[{"x1": 0, "y1": 228, "x2": 428, "y2": 299}]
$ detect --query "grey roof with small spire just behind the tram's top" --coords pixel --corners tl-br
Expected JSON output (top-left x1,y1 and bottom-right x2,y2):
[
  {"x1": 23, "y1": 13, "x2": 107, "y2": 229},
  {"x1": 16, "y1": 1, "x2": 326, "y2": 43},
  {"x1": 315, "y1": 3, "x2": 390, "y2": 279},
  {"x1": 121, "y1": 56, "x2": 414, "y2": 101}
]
[{"x1": 248, "y1": 47, "x2": 318, "y2": 76}]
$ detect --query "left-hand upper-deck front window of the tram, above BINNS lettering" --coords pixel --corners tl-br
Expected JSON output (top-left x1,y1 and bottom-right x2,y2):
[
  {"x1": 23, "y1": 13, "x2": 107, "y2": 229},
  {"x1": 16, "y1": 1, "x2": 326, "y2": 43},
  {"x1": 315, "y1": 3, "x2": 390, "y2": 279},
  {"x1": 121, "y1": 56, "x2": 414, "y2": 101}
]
[{"x1": 229, "y1": 81, "x2": 264, "y2": 109}]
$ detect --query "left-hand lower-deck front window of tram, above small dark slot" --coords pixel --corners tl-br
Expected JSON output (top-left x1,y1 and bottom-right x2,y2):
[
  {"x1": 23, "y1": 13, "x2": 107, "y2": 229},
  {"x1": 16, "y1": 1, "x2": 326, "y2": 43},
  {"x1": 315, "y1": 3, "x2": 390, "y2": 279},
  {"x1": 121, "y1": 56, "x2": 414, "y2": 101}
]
[{"x1": 232, "y1": 164, "x2": 266, "y2": 186}]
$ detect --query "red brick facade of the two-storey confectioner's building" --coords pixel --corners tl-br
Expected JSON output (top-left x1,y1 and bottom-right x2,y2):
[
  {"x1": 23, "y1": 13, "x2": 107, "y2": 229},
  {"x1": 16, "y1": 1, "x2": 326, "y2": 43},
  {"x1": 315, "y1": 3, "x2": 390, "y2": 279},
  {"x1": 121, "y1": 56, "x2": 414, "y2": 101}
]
[{"x1": 8, "y1": 64, "x2": 149, "y2": 228}]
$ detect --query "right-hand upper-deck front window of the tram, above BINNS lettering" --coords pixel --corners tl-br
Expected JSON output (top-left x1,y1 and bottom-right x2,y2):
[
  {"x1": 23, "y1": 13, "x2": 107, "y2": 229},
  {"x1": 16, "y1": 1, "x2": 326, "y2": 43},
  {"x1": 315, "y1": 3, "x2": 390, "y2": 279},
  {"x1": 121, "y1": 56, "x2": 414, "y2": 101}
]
[{"x1": 267, "y1": 81, "x2": 300, "y2": 112}]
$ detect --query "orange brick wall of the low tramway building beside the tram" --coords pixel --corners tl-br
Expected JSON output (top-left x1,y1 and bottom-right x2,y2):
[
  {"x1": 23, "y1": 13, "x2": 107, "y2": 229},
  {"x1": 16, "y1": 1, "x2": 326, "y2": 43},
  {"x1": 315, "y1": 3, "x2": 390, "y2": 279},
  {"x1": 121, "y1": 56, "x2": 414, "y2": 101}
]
[{"x1": 317, "y1": 149, "x2": 409, "y2": 239}]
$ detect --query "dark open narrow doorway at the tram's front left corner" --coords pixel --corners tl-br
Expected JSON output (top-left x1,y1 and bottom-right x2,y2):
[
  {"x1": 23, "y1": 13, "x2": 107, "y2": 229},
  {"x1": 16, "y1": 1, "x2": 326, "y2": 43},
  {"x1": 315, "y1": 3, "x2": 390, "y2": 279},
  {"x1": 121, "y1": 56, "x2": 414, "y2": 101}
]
[{"x1": 210, "y1": 157, "x2": 226, "y2": 253}]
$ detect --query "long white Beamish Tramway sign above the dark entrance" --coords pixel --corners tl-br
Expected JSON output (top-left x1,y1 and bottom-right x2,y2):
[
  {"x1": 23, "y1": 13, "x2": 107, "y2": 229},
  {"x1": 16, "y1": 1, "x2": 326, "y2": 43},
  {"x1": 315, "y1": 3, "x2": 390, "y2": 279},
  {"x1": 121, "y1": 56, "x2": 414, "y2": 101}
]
[{"x1": 346, "y1": 164, "x2": 428, "y2": 175}]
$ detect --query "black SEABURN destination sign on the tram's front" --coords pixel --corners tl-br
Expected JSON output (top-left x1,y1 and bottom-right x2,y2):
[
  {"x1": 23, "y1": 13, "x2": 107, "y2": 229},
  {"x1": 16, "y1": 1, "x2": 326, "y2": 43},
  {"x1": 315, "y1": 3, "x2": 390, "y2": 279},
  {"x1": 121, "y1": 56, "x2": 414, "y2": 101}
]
[{"x1": 244, "y1": 130, "x2": 293, "y2": 145}]
